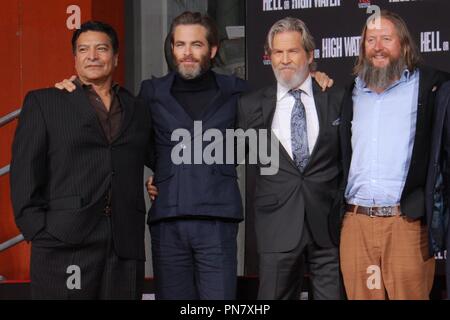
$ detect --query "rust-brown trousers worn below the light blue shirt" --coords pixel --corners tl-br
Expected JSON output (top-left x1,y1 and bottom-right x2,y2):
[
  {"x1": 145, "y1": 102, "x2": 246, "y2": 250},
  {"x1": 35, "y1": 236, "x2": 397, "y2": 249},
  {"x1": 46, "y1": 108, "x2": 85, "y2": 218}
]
[{"x1": 340, "y1": 212, "x2": 435, "y2": 300}]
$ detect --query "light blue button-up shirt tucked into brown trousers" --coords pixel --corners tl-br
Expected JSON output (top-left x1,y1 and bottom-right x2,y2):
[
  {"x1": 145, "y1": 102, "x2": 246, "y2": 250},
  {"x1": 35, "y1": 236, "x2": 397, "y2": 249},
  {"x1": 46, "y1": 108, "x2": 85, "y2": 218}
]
[{"x1": 345, "y1": 70, "x2": 420, "y2": 207}]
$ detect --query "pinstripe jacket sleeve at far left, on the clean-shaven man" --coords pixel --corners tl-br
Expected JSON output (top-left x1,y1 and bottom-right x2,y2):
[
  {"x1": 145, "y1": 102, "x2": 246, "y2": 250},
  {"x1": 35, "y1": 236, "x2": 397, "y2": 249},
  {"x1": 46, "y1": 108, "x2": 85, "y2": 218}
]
[{"x1": 10, "y1": 93, "x2": 47, "y2": 241}]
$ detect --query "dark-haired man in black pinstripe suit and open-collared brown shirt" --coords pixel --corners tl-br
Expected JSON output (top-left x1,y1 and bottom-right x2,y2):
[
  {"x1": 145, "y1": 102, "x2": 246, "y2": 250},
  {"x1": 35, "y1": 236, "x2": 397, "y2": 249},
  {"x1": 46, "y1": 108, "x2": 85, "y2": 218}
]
[{"x1": 11, "y1": 22, "x2": 151, "y2": 299}]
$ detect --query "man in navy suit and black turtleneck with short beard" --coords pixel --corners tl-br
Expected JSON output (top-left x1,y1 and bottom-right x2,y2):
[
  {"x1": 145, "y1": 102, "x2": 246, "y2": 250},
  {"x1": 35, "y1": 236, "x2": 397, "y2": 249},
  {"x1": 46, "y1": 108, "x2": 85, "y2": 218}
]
[{"x1": 140, "y1": 12, "x2": 245, "y2": 300}]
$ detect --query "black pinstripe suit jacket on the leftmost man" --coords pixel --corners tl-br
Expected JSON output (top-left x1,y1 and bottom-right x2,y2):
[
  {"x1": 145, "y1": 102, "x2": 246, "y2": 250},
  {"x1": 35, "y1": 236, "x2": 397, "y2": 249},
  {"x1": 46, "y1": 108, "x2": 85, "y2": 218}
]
[{"x1": 11, "y1": 88, "x2": 152, "y2": 259}]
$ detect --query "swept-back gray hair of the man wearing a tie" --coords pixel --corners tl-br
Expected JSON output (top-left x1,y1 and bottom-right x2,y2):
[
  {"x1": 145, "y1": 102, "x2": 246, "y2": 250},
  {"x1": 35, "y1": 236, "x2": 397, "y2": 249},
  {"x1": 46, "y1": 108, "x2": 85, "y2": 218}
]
[{"x1": 265, "y1": 17, "x2": 316, "y2": 55}]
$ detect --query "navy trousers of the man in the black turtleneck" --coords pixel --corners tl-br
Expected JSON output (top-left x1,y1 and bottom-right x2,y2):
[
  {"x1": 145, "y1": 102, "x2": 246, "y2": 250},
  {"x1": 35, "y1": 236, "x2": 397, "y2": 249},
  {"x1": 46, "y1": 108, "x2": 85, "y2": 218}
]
[{"x1": 150, "y1": 220, "x2": 238, "y2": 300}]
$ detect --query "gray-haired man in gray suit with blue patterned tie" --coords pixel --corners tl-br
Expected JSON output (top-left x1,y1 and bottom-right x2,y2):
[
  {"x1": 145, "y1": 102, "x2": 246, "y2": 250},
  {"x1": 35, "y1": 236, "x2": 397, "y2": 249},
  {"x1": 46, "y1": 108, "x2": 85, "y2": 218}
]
[{"x1": 238, "y1": 18, "x2": 344, "y2": 299}]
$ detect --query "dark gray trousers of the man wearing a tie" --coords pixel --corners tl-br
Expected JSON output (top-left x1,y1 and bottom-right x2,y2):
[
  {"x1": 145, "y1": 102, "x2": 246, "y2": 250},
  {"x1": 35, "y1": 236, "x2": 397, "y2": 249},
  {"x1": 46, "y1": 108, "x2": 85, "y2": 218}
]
[{"x1": 258, "y1": 226, "x2": 343, "y2": 300}]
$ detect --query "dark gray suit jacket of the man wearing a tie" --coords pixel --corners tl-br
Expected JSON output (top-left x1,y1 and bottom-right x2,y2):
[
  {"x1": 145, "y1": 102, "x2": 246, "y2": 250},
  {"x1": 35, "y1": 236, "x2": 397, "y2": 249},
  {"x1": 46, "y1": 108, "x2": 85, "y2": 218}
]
[{"x1": 237, "y1": 84, "x2": 344, "y2": 253}]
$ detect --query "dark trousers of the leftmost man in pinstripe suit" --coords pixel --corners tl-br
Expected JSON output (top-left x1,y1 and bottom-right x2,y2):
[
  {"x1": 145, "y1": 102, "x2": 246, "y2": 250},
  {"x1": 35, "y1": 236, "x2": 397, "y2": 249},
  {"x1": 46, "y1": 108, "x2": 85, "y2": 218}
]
[{"x1": 31, "y1": 216, "x2": 144, "y2": 300}]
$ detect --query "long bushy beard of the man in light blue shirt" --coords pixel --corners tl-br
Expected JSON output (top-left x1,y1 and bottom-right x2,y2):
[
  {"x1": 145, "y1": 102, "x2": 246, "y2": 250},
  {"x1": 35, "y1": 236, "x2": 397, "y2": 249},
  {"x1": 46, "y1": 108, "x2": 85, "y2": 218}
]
[{"x1": 358, "y1": 57, "x2": 406, "y2": 89}]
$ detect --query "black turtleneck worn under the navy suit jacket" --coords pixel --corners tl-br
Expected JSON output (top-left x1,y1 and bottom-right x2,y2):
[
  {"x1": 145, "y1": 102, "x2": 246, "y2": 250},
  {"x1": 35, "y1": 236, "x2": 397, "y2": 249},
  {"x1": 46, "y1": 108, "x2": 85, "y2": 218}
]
[{"x1": 171, "y1": 70, "x2": 219, "y2": 121}]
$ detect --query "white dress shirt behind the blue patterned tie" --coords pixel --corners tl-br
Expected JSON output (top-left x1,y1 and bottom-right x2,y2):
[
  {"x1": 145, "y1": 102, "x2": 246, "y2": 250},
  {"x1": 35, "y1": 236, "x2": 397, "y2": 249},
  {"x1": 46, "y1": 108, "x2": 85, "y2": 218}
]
[{"x1": 272, "y1": 76, "x2": 319, "y2": 159}]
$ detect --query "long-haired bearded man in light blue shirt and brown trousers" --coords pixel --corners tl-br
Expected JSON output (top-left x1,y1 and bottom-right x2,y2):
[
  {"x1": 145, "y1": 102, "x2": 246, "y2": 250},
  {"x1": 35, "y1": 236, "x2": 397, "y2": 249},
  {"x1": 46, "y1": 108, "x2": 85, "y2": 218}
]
[{"x1": 340, "y1": 11, "x2": 444, "y2": 300}]
